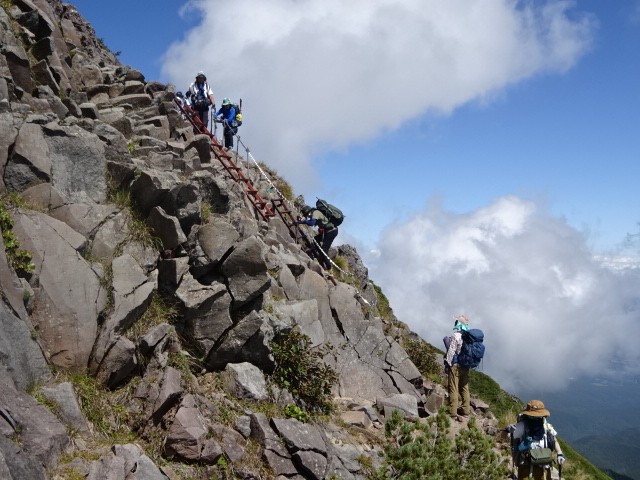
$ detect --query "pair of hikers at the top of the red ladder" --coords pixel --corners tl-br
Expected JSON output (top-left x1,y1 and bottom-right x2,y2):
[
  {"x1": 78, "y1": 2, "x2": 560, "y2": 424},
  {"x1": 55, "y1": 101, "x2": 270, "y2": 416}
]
[{"x1": 176, "y1": 71, "x2": 242, "y2": 150}]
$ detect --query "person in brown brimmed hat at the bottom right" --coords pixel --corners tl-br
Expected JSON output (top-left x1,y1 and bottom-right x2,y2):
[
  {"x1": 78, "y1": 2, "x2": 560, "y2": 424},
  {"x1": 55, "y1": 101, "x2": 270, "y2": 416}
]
[{"x1": 507, "y1": 400, "x2": 565, "y2": 480}]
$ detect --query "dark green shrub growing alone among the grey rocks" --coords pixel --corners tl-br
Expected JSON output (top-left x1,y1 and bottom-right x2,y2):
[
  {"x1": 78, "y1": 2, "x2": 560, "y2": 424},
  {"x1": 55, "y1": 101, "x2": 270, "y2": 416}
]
[{"x1": 271, "y1": 328, "x2": 338, "y2": 413}]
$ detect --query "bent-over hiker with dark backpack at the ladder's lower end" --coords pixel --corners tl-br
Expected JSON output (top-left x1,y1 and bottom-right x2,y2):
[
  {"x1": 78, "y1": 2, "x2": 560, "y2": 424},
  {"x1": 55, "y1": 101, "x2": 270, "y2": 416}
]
[{"x1": 296, "y1": 199, "x2": 344, "y2": 270}]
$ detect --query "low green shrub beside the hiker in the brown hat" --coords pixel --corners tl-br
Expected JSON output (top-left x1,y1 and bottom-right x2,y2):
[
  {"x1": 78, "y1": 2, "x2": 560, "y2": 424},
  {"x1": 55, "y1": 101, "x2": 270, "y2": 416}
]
[{"x1": 370, "y1": 410, "x2": 509, "y2": 480}]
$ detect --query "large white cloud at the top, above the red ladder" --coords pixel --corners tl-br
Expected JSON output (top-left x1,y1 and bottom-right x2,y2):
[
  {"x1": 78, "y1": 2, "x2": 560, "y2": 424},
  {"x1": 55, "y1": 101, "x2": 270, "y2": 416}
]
[{"x1": 163, "y1": 0, "x2": 594, "y2": 184}]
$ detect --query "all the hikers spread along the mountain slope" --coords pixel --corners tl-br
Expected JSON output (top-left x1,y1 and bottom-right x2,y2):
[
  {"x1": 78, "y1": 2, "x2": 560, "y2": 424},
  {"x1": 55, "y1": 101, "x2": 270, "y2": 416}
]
[{"x1": 176, "y1": 71, "x2": 565, "y2": 480}]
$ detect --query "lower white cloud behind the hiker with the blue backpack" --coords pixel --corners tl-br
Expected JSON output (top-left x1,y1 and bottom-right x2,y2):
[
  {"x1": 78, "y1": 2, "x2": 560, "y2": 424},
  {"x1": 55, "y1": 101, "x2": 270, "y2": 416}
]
[{"x1": 368, "y1": 197, "x2": 640, "y2": 391}]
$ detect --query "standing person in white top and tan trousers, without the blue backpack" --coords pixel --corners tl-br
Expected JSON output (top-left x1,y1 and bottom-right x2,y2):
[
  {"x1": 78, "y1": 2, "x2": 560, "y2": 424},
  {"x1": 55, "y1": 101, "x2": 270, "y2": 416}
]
[{"x1": 444, "y1": 315, "x2": 471, "y2": 421}]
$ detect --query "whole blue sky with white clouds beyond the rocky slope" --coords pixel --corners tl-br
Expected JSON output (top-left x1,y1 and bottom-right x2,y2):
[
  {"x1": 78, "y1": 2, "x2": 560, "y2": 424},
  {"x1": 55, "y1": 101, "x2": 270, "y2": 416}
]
[{"x1": 74, "y1": 0, "x2": 640, "y2": 388}]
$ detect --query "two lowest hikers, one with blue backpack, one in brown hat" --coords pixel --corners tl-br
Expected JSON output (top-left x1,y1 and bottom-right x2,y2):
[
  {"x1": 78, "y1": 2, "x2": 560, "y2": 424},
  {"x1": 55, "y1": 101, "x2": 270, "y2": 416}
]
[{"x1": 443, "y1": 315, "x2": 565, "y2": 480}]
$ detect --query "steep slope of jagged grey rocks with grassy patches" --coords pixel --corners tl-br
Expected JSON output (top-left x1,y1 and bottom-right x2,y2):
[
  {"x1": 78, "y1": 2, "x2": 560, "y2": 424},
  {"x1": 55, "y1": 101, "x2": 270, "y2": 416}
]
[{"x1": 0, "y1": 0, "x2": 596, "y2": 480}]
